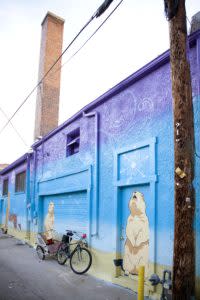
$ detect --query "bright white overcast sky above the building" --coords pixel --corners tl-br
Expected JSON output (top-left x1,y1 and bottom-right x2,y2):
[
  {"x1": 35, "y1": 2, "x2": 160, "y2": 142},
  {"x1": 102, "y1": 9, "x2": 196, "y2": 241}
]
[{"x1": 0, "y1": 0, "x2": 200, "y2": 163}]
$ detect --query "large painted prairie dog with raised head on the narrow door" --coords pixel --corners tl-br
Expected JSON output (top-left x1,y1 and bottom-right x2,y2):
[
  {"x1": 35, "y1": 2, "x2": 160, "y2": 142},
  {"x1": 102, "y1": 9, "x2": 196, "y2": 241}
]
[{"x1": 123, "y1": 192, "x2": 149, "y2": 274}]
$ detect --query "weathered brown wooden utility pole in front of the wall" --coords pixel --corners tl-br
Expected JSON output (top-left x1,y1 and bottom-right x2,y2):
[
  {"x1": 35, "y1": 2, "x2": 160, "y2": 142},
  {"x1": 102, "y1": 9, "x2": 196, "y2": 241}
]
[{"x1": 164, "y1": 0, "x2": 195, "y2": 300}]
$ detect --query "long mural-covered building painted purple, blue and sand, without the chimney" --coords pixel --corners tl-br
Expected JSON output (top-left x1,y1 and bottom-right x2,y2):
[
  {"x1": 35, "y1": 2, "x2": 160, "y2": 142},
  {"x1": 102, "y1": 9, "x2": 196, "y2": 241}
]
[{"x1": 0, "y1": 11, "x2": 200, "y2": 294}]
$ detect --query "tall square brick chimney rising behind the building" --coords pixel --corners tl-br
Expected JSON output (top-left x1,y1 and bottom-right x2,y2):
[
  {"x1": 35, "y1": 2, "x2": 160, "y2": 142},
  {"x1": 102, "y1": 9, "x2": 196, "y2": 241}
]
[{"x1": 34, "y1": 12, "x2": 64, "y2": 140}]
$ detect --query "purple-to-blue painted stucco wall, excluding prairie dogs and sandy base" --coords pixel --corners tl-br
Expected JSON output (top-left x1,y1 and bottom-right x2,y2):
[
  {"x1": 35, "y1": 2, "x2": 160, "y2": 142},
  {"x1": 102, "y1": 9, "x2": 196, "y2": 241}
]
[{"x1": 0, "y1": 31, "x2": 200, "y2": 290}]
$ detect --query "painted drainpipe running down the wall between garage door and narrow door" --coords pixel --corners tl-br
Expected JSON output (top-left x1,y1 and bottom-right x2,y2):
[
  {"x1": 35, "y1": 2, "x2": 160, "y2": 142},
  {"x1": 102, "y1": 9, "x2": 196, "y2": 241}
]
[{"x1": 83, "y1": 111, "x2": 99, "y2": 237}]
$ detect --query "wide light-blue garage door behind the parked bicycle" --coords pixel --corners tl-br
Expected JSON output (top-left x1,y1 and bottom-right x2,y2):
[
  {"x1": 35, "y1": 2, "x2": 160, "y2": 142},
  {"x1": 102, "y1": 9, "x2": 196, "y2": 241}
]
[{"x1": 42, "y1": 191, "x2": 89, "y2": 235}]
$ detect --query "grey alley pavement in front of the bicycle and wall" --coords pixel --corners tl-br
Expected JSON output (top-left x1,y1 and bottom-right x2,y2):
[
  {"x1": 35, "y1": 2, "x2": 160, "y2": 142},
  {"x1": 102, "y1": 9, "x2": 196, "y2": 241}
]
[{"x1": 0, "y1": 234, "x2": 137, "y2": 300}]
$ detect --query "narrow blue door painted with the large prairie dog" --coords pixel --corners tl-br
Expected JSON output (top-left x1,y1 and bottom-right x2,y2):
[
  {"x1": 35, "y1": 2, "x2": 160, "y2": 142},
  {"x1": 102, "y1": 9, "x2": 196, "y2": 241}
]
[{"x1": 119, "y1": 184, "x2": 152, "y2": 274}]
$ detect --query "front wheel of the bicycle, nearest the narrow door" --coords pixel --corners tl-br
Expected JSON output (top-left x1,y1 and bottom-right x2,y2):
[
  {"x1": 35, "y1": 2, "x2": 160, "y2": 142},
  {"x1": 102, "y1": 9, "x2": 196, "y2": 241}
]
[{"x1": 70, "y1": 247, "x2": 92, "y2": 274}]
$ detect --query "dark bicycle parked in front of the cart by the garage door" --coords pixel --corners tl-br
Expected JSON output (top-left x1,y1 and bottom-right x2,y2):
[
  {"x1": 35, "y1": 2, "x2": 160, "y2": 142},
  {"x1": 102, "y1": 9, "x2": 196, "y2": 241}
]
[{"x1": 57, "y1": 230, "x2": 92, "y2": 274}]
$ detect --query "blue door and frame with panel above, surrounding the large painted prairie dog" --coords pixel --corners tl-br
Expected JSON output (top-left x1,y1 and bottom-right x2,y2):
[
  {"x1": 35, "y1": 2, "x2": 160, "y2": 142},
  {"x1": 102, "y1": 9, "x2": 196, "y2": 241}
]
[{"x1": 114, "y1": 138, "x2": 157, "y2": 263}]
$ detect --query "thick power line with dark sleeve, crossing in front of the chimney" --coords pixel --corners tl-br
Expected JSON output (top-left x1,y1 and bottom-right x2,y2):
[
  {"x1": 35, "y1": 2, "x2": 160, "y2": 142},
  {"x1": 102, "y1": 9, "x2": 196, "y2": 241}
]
[{"x1": 0, "y1": 0, "x2": 113, "y2": 134}]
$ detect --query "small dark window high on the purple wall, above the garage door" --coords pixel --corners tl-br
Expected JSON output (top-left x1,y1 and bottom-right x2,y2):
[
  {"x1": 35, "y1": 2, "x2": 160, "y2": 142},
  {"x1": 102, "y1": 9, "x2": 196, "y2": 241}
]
[{"x1": 67, "y1": 128, "x2": 80, "y2": 156}]
